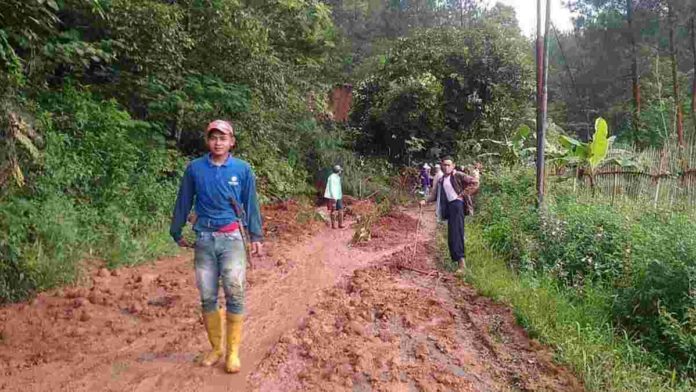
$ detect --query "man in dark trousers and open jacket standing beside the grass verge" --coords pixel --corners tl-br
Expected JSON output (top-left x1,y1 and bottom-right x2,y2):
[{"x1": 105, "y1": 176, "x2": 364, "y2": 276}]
[{"x1": 420, "y1": 157, "x2": 479, "y2": 272}]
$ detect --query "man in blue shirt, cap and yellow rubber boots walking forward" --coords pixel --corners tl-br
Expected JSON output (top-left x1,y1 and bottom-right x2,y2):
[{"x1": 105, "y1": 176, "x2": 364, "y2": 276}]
[{"x1": 170, "y1": 120, "x2": 263, "y2": 373}]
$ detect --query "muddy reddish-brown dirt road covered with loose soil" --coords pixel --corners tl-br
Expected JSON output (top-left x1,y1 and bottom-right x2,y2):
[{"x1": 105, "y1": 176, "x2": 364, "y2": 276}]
[{"x1": 0, "y1": 207, "x2": 582, "y2": 392}]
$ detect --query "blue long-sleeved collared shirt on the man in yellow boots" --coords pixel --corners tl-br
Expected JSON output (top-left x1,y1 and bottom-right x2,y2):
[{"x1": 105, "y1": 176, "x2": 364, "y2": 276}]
[{"x1": 169, "y1": 154, "x2": 263, "y2": 242}]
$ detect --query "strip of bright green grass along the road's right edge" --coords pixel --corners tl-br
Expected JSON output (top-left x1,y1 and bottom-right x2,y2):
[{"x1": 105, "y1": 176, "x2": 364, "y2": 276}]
[{"x1": 452, "y1": 223, "x2": 694, "y2": 392}]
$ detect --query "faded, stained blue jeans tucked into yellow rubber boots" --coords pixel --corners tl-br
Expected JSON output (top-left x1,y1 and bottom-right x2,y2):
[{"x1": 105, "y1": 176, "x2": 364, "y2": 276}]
[{"x1": 194, "y1": 230, "x2": 246, "y2": 314}]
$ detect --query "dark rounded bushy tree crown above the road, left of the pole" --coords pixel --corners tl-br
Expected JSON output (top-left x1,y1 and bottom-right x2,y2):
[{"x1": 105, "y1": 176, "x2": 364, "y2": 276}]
[{"x1": 352, "y1": 24, "x2": 531, "y2": 162}]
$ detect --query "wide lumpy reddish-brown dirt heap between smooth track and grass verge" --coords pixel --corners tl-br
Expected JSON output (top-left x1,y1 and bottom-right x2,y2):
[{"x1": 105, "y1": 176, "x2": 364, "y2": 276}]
[{"x1": 250, "y1": 233, "x2": 582, "y2": 391}]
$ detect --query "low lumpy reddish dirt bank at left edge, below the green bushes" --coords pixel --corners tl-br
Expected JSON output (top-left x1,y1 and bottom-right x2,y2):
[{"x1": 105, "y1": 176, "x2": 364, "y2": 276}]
[{"x1": 0, "y1": 258, "x2": 199, "y2": 389}]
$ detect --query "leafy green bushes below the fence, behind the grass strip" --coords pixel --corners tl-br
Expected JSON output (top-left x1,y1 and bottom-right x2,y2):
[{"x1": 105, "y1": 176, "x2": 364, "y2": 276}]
[{"x1": 478, "y1": 170, "x2": 696, "y2": 377}]
